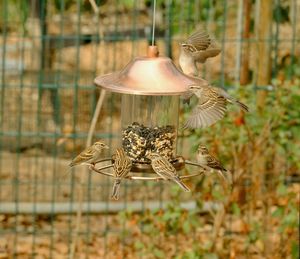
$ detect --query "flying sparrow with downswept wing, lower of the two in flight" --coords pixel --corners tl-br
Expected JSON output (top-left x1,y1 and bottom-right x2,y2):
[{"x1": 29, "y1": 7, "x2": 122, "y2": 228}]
[{"x1": 183, "y1": 83, "x2": 249, "y2": 129}]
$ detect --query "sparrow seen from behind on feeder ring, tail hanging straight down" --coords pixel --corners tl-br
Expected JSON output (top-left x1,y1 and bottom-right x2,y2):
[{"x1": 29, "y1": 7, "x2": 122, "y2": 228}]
[{"x1": 111, "y1": 148, "x2": 132, "y2": 200}]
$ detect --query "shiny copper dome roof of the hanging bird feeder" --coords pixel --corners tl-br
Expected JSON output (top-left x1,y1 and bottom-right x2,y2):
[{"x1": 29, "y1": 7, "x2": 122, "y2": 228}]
[{"x1": 94, "y1": 46, "x2": 206, "y2": 95}]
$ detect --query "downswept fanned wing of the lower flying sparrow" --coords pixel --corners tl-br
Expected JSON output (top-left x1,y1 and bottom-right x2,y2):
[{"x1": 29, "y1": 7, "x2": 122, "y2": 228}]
[{"x1": 183, "y1": 87, "x2": 226, "y2": 128}]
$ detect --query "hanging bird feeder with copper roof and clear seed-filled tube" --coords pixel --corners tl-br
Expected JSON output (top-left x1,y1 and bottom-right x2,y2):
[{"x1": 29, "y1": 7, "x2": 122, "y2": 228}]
[{"x1": 95, "y1": 46, "x2": 206, "y2": 180}]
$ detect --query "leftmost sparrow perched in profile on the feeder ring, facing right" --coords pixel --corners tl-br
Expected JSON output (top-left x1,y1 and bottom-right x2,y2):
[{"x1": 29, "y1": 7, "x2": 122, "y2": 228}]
[{"x1": 69, "y1": 141, "x2": 108, "y2": 167}]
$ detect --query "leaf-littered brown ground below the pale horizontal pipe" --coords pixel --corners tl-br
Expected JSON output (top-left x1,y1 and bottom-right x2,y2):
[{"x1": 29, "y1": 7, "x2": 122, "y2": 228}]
[{"x1": 0, "y1": 204, "x2": 295, "y2": 259}]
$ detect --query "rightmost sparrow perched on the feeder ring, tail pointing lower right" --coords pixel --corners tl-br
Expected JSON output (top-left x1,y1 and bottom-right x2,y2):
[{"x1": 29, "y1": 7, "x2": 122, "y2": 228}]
[{"x1": 196, "y1": 145, "x2": 232, "y2": 184}]
